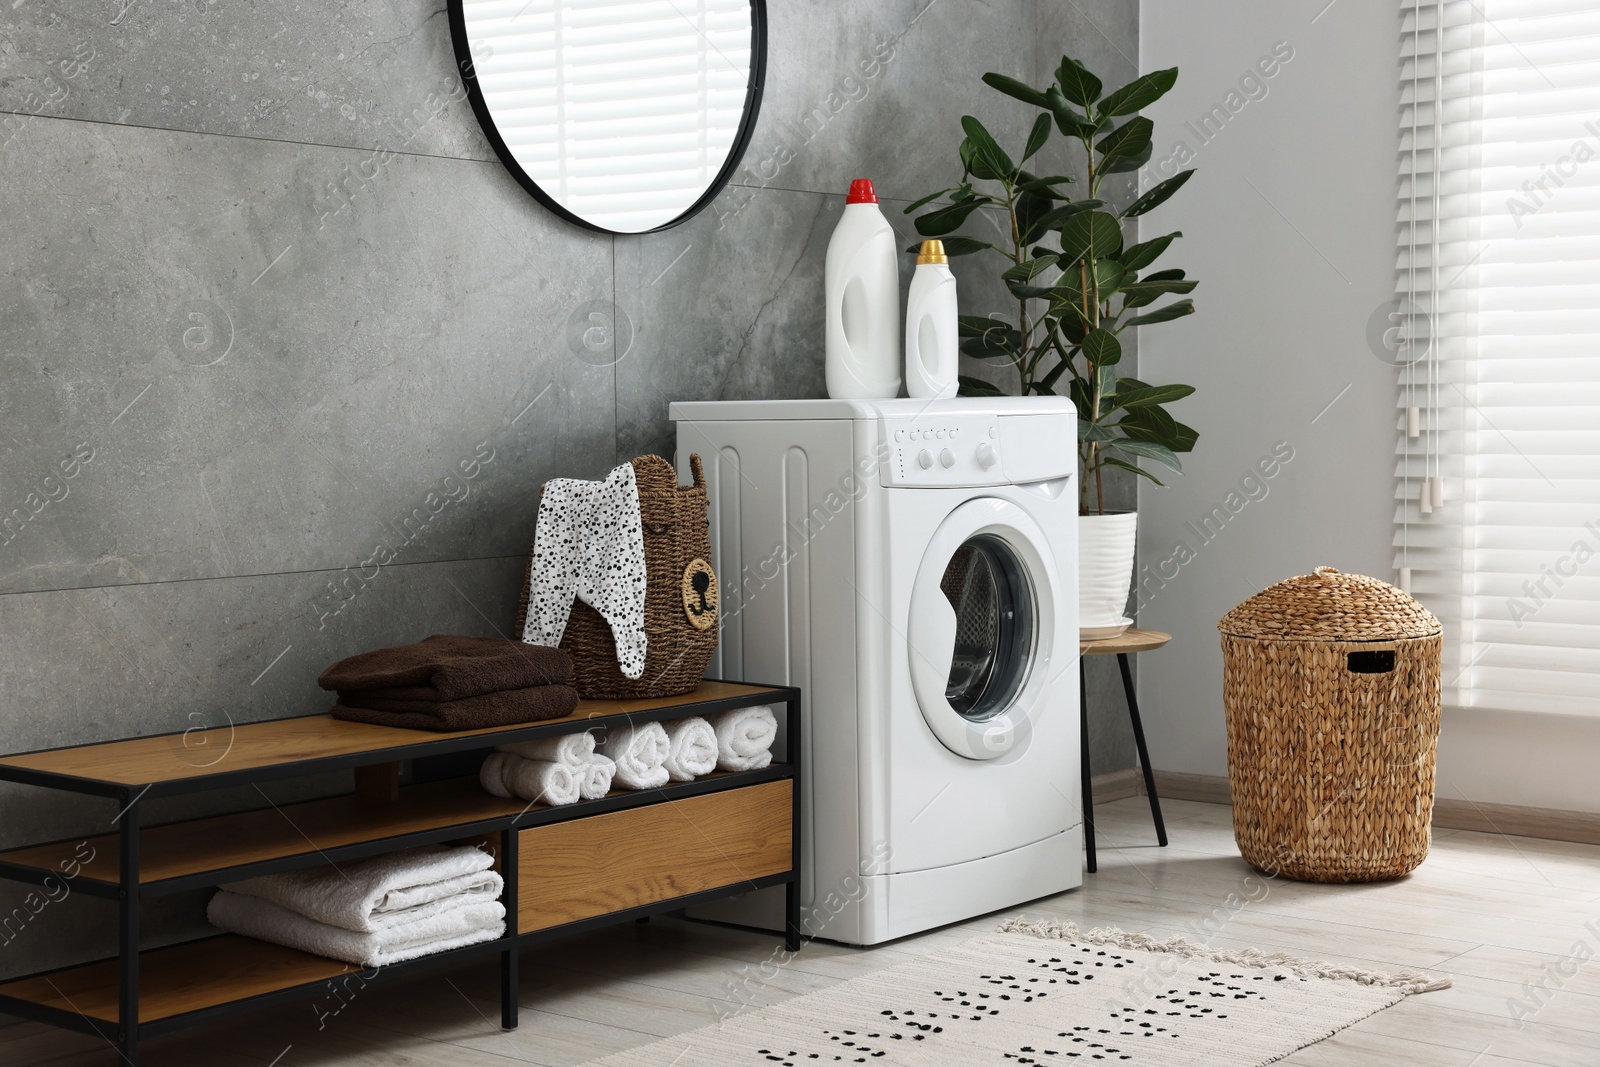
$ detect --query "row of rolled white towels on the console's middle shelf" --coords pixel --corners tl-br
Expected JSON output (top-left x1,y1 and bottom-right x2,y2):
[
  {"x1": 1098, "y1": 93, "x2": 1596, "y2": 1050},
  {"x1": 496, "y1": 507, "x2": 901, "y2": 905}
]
[{"x1": 478, "y1": 707, "x2": 778, "y2": 805}]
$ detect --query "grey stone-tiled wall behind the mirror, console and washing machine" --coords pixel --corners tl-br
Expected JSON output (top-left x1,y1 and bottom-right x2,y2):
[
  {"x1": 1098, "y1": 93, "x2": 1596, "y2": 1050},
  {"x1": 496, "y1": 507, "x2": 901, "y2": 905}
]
[{"x1": 0, "y1": 0, "x2": 1138, "y2": 974}]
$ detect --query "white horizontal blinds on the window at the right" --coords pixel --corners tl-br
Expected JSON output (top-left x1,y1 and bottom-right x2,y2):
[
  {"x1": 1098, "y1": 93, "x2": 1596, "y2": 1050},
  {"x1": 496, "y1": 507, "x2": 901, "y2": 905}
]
[{"x1": 1395, "y1": 0, "x2": 1600, "y2": 715}]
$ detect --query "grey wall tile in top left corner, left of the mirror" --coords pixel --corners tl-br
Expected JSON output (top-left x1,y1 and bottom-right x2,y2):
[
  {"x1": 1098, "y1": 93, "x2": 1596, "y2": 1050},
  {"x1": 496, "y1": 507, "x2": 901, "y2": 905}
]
[{"x1": 0, "y1": 0, "x2": 493, "y2": 160}]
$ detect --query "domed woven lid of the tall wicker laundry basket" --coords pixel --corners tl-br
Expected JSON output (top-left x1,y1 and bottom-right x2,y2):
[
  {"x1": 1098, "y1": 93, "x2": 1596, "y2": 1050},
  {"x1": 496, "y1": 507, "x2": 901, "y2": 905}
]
[{"x1": 1216, "y1": 566, "x2": 1438, "y2": 641}]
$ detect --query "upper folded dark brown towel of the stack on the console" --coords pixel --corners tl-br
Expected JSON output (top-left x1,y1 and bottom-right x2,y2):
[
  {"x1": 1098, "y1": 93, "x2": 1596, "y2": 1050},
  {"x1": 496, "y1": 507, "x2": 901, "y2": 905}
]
[{"x1": 317, "y1": 633, "x2": 573, "y2": 702}]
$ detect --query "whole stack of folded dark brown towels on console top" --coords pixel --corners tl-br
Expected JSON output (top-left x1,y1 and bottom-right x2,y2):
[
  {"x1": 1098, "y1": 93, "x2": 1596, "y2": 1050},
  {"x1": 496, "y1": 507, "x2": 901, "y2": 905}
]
[{"x1": 317, "y1": 633, "x2": 578, "y2": 729}]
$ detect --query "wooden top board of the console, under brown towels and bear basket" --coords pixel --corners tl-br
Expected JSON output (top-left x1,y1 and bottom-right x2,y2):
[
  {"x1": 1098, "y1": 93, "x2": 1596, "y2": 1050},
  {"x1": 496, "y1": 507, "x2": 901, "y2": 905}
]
[{"x1": 0, "y1": 681, "x2": 782, "y2": 792}]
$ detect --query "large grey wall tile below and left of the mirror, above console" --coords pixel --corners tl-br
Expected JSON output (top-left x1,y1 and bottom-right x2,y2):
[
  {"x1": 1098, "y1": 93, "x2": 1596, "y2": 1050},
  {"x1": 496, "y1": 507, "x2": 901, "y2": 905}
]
[{"x1": 0, "y1": 118, "x2": 613, "y2": 601}]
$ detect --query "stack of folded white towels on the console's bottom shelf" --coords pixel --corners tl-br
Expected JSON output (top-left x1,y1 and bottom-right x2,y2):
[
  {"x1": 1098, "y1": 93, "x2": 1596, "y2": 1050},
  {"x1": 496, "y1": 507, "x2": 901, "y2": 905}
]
[{"x1": 206, "y1": 845, "x2": 506, "y2": 968}]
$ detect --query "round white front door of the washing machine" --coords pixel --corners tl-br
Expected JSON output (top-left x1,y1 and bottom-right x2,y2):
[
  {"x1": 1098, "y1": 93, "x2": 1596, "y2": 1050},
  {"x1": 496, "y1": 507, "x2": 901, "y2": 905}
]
[{"x1": 906, "y1": 498, "x2": 1059, "y2": 760}]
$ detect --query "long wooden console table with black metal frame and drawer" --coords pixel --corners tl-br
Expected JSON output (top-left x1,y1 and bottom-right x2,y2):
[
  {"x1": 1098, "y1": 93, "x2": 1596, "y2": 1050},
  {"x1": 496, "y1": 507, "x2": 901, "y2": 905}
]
[{"x1": 0, "y1": 681, "x2": 800, "y2": 1067}]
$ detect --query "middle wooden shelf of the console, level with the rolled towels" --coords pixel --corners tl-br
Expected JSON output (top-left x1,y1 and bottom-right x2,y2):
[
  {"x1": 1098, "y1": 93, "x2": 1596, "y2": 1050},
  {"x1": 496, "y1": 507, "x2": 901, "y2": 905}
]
[{"x1": 0, "y1": 765, "x2": 782, "y2": 886}]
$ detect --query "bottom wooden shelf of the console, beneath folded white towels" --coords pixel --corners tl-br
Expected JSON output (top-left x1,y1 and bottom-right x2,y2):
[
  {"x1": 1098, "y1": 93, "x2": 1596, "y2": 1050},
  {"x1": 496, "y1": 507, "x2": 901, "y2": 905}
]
[{"x1": 0, "y1": 934, "x2": 360, "y2": 1025}]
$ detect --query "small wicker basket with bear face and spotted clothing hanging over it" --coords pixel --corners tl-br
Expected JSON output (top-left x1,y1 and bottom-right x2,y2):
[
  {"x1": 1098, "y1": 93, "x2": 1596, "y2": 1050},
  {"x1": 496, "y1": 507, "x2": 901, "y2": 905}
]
[{"x1": 517, "y1": 454, "x2": 717, "y2": 699}]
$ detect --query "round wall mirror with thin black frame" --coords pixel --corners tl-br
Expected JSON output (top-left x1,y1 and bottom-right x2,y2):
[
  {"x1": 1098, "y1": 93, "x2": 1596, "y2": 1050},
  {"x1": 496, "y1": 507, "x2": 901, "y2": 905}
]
[{"x1": 450, "y1": 0, "x2": 766, "y2": 234}]
